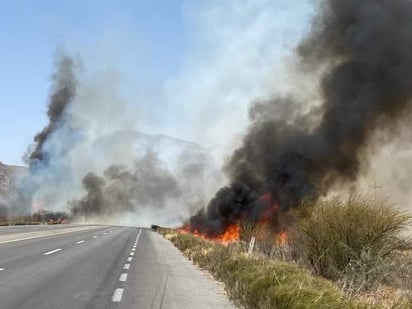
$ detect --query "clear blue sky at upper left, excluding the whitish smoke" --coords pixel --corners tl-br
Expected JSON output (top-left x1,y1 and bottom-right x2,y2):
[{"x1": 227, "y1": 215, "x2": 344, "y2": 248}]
[{"x1": 0, "y1": 0, "x2": 308, "y2": 164}]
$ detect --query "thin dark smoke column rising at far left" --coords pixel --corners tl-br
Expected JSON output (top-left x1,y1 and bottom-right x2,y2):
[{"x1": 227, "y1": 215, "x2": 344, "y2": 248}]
[{"x1": 28, "y1": 55, "x2": 76, "y2": 171}]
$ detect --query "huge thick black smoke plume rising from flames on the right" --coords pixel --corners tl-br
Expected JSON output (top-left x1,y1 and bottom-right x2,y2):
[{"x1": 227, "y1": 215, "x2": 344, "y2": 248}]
[{"x1": 190, "y1": 0, "x2": 412, "y2": 234}]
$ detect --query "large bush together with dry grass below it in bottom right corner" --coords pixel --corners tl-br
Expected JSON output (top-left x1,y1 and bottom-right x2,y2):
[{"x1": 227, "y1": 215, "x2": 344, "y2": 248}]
[{"x1": 294, "y1": 196, "x2": 412, "y2": 308}]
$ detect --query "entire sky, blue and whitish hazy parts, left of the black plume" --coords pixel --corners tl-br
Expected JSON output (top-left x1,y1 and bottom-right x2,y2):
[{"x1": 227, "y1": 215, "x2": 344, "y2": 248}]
[{"x1": 0, "y1": 0, "x2": 312, "y2": 165}]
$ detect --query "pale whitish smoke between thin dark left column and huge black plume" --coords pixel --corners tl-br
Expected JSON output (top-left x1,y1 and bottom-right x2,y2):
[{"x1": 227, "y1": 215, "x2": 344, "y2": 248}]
[{"x1": 15, "y1": 0, "x2": 311, "y2": 224}]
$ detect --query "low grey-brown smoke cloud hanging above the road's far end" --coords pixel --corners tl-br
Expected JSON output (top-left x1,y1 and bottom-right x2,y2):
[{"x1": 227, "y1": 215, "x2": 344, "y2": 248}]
[{"x1": 70, "y1": 152, "x2": 181, "y2": 219}]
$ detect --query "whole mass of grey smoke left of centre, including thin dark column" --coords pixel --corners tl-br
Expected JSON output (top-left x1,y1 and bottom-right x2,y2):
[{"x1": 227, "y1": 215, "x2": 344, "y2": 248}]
[{"x1": 12, "y1": 50, "x2": 224, "y2": 221}]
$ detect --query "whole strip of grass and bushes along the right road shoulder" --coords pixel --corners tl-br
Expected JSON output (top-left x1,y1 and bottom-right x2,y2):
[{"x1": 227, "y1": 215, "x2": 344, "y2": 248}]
[{"x1": 158, "y1": 196, "x2": 412, "y2": 308}]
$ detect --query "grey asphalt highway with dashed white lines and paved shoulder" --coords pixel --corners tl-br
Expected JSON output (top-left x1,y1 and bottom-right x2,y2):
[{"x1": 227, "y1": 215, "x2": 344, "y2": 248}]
[{"x1": 0, "y1": 225, "x2": 234, "y2": 309}]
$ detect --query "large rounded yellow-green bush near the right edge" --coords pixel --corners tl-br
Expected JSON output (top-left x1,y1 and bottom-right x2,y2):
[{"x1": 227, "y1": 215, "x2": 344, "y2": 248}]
[{"x1": 295, "y1": 196, "x2": 412, "y2": 288}]
